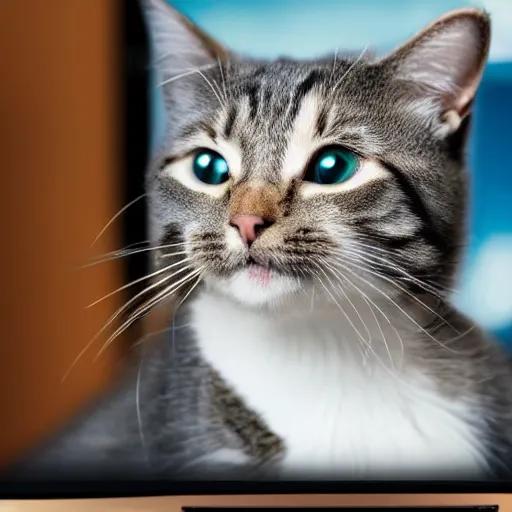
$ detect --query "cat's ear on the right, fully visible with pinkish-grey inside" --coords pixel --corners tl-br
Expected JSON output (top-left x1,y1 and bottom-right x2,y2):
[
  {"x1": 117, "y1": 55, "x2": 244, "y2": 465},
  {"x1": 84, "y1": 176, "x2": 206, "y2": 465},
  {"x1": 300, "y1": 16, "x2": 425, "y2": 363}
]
[{"x1": 381, "y1": 8, "x2": 491, "y2": 133}]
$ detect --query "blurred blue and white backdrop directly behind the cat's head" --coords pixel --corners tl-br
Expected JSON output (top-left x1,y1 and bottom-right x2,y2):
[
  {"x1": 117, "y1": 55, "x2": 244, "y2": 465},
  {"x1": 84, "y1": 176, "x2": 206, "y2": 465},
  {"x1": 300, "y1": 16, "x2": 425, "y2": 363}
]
[{"x1": 155, "y1": 0, "x2": 512, "y2": 346}]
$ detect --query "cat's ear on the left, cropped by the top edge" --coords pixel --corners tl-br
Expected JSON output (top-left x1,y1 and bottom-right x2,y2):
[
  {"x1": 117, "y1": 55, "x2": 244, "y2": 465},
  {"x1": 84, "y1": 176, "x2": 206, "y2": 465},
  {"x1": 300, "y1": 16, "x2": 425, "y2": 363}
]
[{"x1": 141, "y1": 0, "x2": 228, "y2": 114}]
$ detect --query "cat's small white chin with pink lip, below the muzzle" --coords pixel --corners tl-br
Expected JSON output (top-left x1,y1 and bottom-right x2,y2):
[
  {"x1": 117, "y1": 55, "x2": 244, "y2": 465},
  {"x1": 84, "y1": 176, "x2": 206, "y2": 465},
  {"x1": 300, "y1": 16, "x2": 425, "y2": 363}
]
[{"x1": 212, "y1": 266, "x2": 302, "y2": 307}]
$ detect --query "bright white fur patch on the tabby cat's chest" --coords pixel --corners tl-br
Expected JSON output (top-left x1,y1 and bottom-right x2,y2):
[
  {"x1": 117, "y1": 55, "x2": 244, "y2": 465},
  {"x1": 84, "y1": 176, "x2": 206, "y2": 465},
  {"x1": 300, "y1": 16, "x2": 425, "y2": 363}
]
[{"x1": 192, "y1": 293, "x2": 485, "y2": 478}]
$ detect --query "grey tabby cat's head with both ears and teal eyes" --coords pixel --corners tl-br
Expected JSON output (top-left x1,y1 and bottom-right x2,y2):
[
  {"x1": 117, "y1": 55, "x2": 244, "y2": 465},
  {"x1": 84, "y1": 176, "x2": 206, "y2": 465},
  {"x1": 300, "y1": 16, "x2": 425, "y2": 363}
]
[{"x1": 140, "y1": 0, "x2": 490, "y2": 305}]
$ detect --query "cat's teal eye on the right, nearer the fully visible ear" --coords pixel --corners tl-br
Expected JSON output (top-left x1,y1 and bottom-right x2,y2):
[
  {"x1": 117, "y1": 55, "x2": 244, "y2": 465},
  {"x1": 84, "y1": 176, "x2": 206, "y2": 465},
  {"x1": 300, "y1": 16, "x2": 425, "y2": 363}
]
[{"x1": 304, "y1": 146, "x2": 359, "y2": 185}]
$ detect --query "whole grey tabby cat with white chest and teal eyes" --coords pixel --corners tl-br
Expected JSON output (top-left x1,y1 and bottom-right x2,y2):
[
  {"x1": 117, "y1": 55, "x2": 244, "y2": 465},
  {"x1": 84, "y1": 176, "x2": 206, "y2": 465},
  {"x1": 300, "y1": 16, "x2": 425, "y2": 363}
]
[{"x1": 7, "y1": 0, "x2": 512, "y2": 480}]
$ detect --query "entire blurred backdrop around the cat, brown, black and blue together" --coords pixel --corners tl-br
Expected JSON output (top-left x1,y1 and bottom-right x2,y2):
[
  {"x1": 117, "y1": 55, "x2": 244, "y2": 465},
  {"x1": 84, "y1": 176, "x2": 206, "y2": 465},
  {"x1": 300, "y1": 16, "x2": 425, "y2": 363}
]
[{"x1": 0, "y1": 0, "x2": 512, "y2": 472}]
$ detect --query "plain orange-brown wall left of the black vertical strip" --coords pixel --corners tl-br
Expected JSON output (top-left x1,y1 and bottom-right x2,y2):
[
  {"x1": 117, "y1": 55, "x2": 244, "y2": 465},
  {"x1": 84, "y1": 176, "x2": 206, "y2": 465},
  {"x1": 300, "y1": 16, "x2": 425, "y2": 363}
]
[{"x1": 0, "y1": 0, "x2": 122, "y2": 464}]
